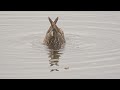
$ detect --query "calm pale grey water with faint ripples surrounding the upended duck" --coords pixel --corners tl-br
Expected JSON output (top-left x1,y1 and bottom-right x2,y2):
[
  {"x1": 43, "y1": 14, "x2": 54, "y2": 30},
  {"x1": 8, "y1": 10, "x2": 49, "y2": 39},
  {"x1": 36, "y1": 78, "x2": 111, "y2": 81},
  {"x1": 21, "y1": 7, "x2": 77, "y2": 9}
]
[{"x1": 0, "y1": 11, "x2": 120, "y2": 78}]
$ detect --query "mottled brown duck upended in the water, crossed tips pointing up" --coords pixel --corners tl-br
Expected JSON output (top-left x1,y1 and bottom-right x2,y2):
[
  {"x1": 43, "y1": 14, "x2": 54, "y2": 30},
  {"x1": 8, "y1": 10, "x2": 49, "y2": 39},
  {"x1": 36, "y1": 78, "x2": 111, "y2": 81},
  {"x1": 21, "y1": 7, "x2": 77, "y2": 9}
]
[{"x1": 44, "y1": 17, "x2": 66, "y2": 50}]
